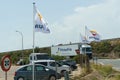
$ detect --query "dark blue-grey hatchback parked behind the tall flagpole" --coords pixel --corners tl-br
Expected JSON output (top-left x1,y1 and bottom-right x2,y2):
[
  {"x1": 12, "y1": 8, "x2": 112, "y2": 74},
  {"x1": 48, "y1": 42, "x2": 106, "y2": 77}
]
[{"x1": 14, "y1": 64, "x2": 61, "y2": 80}]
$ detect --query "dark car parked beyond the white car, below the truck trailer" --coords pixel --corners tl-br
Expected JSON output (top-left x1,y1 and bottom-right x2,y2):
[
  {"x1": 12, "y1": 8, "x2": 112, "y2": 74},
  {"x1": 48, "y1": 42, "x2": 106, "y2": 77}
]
[{"x1": 58, "y1": 60, "x2": 77, "y2": 70}]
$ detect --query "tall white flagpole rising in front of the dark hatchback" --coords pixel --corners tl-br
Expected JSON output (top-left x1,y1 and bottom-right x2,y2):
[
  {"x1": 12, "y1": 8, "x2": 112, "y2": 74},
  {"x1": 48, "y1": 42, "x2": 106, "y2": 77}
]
[{"x1": 32, "y1": 2, "x2": 35, "y2": 80}]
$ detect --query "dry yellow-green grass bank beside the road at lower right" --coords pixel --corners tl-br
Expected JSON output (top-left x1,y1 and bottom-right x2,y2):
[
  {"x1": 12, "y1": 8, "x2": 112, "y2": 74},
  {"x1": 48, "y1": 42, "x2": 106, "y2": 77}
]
[{"x1": 70, "y1": 64, "x2": 120, "y2": 80}]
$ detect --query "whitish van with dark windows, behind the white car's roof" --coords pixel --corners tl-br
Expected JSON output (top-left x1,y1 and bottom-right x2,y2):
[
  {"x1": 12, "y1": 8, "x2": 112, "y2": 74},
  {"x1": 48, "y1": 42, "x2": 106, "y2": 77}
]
[{"x1": 29, "y1": 53, "x2": 52, "y2": 63}]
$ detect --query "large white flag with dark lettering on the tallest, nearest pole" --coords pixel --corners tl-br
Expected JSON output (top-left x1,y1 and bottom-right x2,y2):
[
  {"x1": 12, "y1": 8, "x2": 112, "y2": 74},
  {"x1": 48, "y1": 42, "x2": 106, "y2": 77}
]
[{"x1": 34, "y1": 7, "x2": 50, "y2": 33}]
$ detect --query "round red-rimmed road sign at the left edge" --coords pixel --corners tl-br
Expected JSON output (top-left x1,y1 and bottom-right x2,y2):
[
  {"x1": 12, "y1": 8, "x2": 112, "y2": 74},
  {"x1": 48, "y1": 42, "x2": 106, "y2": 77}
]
[{"x1": 1, "y1": 55, "x2": 11, "y2": 72}]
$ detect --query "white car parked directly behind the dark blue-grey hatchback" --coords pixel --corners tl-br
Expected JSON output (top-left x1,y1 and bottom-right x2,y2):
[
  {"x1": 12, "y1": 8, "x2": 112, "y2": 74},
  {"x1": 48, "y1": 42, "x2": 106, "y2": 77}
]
[{"x1": 34, "y1": 60, "x2": 71, "y2": 76}]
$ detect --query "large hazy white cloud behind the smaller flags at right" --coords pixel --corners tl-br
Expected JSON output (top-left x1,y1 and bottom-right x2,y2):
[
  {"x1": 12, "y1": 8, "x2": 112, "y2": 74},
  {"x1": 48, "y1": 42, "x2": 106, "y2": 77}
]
[{"x1": 53, "y1": 0, "x2": 120, "y2": 43}]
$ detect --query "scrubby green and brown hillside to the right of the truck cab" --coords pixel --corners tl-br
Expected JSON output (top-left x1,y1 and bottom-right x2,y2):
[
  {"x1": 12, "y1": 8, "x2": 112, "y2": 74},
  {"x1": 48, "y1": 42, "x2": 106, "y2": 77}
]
[{"x1": 91, "y1": 39, "x2": 120, "y2": 58}]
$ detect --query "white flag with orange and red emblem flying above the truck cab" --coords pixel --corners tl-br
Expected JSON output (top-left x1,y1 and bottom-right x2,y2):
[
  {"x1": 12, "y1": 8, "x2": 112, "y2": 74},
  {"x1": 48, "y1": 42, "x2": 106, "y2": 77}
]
[{"x1": 86, "y1": 27, "x2": 101, "y2": 42}]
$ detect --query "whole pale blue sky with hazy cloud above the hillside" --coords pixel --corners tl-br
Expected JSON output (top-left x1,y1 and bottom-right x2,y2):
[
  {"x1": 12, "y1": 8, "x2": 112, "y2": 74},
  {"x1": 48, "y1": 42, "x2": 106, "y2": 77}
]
[{"x1": 0, "y1": 0, "x2": 120, "y2": 52}]
